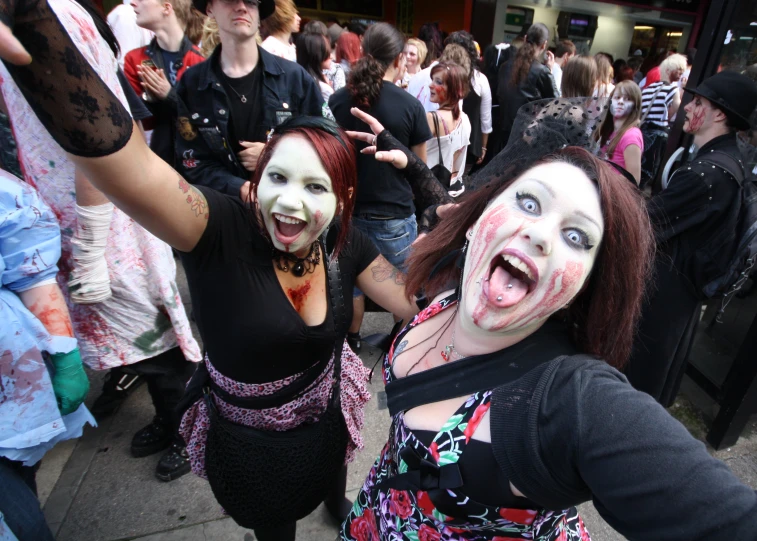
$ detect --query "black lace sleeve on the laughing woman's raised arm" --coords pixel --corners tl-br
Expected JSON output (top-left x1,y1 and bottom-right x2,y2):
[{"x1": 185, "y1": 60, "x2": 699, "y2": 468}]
[{"x1": 0, "y1": 0, "x2": 132, "y2": 157}]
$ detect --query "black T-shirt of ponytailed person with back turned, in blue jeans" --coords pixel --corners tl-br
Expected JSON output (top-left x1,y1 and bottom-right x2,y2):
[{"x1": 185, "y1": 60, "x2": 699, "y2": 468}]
[{"x1": 329, "y1": 81, "x2": 431, "y2": 218}]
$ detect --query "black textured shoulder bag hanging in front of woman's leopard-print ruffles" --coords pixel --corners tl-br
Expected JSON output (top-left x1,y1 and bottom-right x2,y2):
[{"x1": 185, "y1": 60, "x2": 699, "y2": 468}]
[{"x1": 204, "y1": 248, "x2": 349, "y2": 529}]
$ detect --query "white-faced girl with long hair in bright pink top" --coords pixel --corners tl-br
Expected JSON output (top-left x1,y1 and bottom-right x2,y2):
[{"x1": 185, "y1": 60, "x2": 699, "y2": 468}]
[{"x1": 597, "y1": 81, "x2": 644, "y2": 184}]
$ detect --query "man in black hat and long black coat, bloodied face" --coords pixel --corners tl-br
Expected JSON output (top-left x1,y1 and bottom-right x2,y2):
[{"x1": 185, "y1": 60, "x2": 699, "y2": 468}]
[{"x1": 626, "y1": 72, "x2": 757, "y2": 407}]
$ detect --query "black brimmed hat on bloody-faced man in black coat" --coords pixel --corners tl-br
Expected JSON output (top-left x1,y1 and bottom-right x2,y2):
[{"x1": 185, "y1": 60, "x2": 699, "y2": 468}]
[{"x1": 684, "y1": 71, "x2": 757, "y2": 130}]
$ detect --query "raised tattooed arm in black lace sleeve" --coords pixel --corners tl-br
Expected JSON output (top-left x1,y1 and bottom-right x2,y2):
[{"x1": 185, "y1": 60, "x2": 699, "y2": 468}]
[{"x1": 0, "y1": 0, "x2": 208, "y2": 251}]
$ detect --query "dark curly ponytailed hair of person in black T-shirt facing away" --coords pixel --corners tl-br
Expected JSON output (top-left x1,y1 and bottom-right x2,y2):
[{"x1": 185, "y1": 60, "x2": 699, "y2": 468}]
[{"x1": 347, "y1": 23, "x2": 405, "y2": 109}]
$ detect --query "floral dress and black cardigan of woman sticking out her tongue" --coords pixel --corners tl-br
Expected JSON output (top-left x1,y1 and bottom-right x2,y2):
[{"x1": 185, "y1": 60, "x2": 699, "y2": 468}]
[{"x1": 339, "y1": 294, "x2": 757, "y2": 541}]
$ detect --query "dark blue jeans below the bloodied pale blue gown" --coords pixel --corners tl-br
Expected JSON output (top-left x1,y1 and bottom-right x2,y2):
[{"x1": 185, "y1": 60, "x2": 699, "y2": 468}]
[{"x1": 0, "y1": 457, "x2": 55, "y2": 541}]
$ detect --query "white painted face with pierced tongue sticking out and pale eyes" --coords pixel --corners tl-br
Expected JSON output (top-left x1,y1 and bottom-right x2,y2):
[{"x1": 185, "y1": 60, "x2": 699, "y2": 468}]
[{"x1": 460, "y1": 162, "x2": 604, "y2": 333}]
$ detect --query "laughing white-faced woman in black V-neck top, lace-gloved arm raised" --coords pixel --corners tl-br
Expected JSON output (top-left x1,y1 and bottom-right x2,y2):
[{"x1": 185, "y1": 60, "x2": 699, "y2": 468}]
[{"x1": 0, "y1": 6, "x2": 448, "y2": 541}]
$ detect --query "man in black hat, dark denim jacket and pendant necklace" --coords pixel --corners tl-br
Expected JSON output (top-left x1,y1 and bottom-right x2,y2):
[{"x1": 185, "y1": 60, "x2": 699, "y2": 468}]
[{"x1": 176, "y1": 0, "x2": 325, "y2": 199}]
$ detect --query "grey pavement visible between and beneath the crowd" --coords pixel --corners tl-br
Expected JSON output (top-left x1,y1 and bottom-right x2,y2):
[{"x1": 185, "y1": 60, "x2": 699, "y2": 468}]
[{"x1": 38, "y1": 269, "x2": 757, "y2": 541}]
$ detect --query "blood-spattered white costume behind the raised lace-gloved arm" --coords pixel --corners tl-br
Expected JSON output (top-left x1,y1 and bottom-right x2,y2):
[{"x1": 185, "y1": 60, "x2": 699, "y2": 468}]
[{"x1": 0, "y1": 0, "x2": 201, "y2": 370}]
